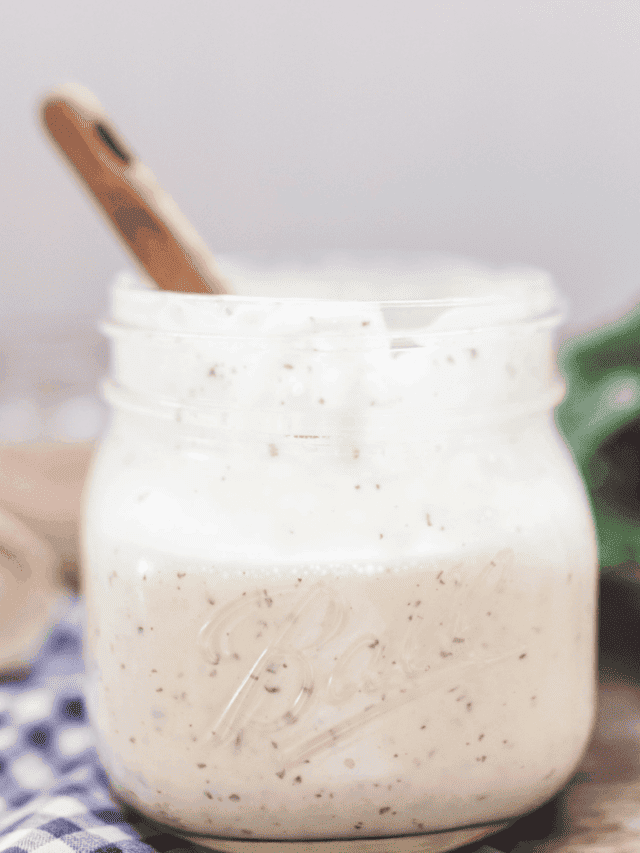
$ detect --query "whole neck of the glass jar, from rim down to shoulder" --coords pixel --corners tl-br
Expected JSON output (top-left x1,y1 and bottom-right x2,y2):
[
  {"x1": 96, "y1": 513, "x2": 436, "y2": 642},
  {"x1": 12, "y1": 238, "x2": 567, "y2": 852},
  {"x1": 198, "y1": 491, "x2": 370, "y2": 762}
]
[{"x1": 102, "y1": 256, "x2": 561, "y2": 437}]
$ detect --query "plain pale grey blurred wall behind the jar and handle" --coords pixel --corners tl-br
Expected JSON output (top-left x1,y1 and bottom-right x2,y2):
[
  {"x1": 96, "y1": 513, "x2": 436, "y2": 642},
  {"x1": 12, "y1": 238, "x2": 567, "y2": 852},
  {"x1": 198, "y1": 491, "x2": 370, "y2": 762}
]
[{"x1": 0, "y1": 0, "x2": 640, "y2": 336}]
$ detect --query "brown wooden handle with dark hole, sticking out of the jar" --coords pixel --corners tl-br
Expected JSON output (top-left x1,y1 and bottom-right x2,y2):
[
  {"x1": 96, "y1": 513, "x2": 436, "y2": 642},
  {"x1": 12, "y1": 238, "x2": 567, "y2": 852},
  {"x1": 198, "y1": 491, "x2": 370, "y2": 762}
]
[{"x1": 41, "y1": 85, "x2": 230, "y2": 294}]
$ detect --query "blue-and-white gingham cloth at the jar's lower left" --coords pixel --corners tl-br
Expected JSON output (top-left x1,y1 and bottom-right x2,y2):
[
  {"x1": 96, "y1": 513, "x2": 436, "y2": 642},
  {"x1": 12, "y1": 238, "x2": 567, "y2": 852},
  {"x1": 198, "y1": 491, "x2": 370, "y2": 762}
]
[{"x1": 0, "y1": 601, "x2": 508, "y2": 853}]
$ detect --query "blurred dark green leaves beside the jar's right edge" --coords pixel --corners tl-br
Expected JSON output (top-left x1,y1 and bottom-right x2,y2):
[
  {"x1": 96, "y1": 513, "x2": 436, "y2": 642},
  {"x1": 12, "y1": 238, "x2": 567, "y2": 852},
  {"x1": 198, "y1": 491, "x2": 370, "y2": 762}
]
[{"x1": 556, "y1": 306, "x2": 640, "y2": 569}]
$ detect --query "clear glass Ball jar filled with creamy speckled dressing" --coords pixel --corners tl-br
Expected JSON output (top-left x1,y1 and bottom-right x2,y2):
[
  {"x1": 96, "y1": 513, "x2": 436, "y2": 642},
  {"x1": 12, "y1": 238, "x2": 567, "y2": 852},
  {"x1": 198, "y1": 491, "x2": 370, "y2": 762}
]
[{"x1": 83, "y1": 268, "x2": 597, "y2": 853}]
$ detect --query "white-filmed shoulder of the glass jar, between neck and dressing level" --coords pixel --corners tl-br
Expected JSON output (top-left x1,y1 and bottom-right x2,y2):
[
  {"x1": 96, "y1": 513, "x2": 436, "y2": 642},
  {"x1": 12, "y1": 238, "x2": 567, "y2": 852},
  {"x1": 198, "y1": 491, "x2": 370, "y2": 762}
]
[{"x1": 84, "y1": 423, "x2": 594, "y2": 561}]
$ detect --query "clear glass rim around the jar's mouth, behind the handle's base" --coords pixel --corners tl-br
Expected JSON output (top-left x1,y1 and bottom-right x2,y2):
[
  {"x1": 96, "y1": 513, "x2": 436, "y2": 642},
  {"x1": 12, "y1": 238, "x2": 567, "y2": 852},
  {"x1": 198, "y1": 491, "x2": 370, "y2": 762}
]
[{"x1": 110, "y1": 260, "x2": 566, "y2": 345}]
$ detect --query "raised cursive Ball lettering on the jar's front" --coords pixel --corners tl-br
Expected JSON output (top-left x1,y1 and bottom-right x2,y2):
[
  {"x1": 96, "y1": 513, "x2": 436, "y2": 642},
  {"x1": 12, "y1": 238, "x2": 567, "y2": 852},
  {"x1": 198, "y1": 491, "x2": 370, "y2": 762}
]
[{"x1": 199, "y1": 549, "x2": 524, "y2": 766}]
